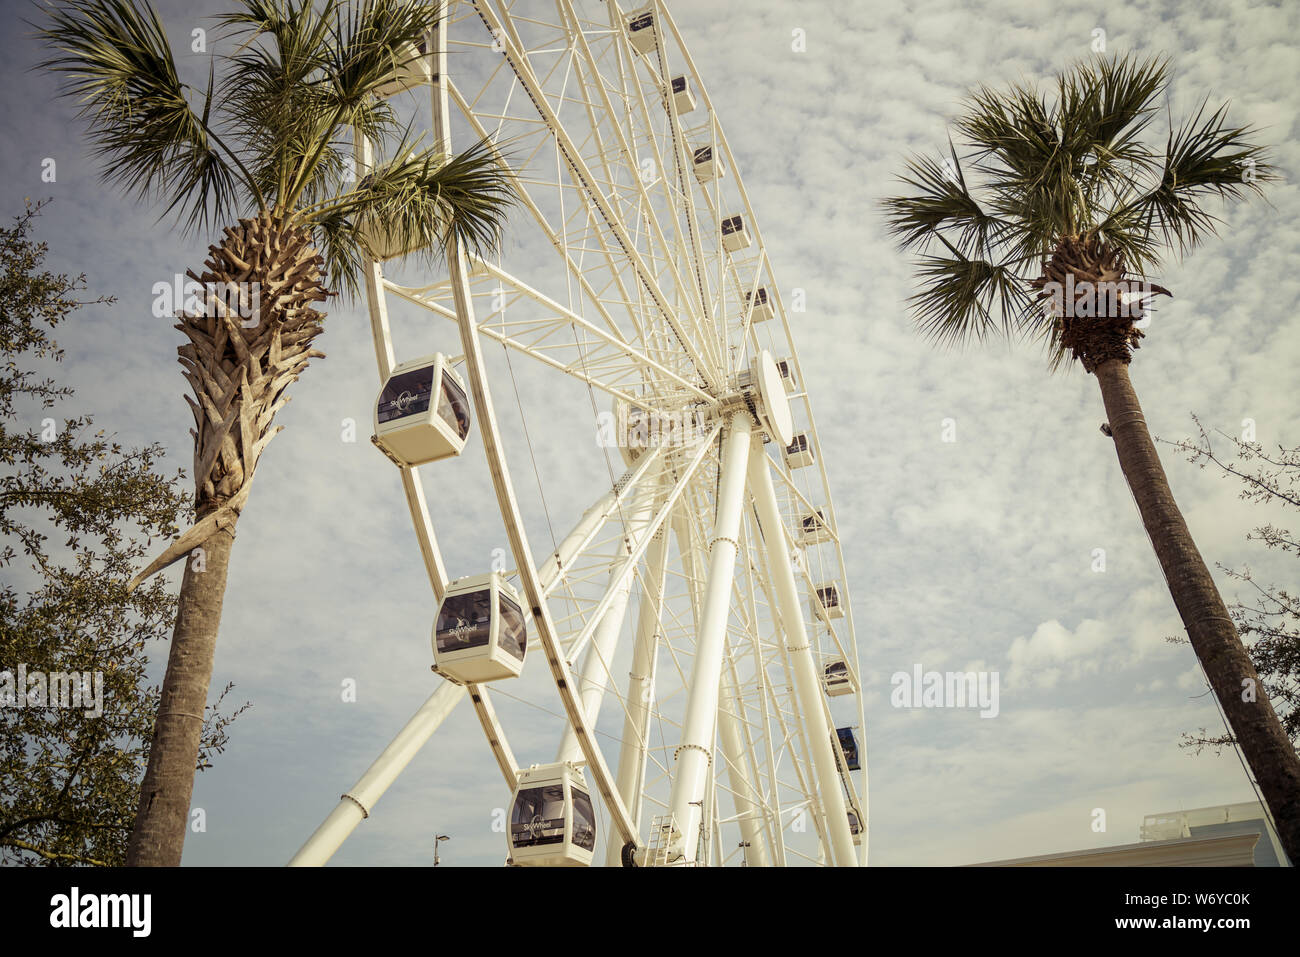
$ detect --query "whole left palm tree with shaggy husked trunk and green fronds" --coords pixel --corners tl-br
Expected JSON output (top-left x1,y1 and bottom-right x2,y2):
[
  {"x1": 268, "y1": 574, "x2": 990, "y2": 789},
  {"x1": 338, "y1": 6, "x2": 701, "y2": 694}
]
[{"x1": 38, "y1": 0, "x2": 514, "y2": 865}]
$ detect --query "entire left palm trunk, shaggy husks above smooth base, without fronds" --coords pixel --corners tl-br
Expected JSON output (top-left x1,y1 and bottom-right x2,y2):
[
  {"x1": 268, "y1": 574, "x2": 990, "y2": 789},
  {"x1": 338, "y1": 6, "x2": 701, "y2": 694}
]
[{"x1": 126, "y1": 211, "x2": 329, "y2": 866}]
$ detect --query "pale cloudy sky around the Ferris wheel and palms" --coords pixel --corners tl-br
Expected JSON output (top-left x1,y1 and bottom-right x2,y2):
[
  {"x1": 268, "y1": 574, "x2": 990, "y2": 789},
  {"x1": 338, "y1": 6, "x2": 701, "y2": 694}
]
[{"x1": 0, "y1": 0, "x2": 1300, "y2": 866}]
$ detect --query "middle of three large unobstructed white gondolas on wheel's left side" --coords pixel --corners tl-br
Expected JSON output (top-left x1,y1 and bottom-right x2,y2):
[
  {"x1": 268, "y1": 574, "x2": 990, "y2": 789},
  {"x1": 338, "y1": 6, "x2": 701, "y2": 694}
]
[{"x1": 433, "y1": 572, "x2": 528, "y2": 684}]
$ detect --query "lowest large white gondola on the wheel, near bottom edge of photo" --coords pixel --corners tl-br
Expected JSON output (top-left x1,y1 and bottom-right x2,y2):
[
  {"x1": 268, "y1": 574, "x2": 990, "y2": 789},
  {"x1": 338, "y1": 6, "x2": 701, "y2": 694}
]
[{"x1": 507, "y1": 765, "x2": 595, "y2": 867}]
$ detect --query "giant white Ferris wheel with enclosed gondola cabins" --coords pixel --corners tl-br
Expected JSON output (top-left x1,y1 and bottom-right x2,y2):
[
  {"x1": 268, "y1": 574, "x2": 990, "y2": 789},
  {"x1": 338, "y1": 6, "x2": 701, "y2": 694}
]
[{"x1": 291, "y1": 0, "x2": 867, "y2": 866}]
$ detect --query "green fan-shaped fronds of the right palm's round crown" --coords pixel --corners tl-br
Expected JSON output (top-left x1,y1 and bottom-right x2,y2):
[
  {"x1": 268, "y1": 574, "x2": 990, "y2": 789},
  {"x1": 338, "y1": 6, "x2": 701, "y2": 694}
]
[{"x1": 884, "y1": 55, "x2": 1277, "y2": 364}]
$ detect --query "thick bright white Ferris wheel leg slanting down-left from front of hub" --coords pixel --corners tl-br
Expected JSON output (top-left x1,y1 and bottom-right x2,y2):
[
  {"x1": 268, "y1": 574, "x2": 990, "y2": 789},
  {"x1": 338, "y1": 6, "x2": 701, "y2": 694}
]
[{"x1": 668, "y1": 411, "x2": 754, "y2": 862}]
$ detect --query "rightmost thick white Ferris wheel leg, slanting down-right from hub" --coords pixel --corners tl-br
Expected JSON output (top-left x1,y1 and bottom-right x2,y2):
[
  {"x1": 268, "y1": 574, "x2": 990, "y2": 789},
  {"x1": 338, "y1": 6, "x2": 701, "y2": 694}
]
[{"x1": 749, "y1": 443, "x2": 858, "y2": 867}]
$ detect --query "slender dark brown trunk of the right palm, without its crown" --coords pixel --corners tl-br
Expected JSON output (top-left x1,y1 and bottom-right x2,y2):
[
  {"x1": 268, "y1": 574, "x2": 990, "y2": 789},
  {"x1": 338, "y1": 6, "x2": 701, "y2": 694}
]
[{"x1": 1096, "y1": 359, "x2": 1300, "y2": 865}]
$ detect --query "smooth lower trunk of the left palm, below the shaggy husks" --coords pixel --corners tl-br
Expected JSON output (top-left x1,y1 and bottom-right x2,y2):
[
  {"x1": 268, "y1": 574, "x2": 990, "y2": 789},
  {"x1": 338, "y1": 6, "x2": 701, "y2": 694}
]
[{"x1": 126, "y1": 525, "x2": 235, "y2": 867}]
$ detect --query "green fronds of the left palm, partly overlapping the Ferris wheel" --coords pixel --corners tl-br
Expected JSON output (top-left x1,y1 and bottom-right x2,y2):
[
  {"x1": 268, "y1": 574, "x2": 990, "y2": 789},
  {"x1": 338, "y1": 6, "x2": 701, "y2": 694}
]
[{"x1": 40, "y1": 0, "x2": 512, "y2": 293}]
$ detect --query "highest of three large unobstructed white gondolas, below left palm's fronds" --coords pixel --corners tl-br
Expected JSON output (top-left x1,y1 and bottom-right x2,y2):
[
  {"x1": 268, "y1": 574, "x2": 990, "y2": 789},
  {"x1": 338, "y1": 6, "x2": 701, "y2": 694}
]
[{"x1": 374, "y1": 352, "x2": 469, "y2": 465}]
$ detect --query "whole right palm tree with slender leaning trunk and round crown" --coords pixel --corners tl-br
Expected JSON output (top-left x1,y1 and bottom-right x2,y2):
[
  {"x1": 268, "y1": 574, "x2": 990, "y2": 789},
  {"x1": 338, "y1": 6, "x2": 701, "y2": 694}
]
[{"x1": 884, "y1": 56, "x2": 1300, "y2": 861}]
